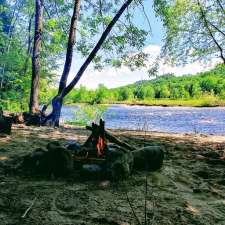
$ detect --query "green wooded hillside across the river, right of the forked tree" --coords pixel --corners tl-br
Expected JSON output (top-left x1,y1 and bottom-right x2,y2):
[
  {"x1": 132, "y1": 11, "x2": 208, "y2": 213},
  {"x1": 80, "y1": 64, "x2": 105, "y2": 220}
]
[{"x1": 63, "y1": 65, "x2": 225, "y2": 104}]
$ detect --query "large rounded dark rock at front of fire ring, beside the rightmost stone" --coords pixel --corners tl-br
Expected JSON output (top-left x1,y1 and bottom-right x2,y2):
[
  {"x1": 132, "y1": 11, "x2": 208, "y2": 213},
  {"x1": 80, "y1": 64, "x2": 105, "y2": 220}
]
[{"x1": 106, "y1": 147, "x2": 134, "y2": 180}]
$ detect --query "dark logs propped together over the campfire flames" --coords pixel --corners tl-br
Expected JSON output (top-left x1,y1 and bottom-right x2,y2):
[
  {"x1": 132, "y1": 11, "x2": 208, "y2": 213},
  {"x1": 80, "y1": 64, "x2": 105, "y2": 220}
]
[{"x1": 84, "y1": 120, "x2": 136, "y2": 151}]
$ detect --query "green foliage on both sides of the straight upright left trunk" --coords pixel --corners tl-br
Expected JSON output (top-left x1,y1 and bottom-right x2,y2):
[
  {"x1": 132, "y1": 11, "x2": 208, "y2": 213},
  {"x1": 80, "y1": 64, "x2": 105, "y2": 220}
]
[{"x1": 0, "y1": 0, "x2": 58, "y2": 111}]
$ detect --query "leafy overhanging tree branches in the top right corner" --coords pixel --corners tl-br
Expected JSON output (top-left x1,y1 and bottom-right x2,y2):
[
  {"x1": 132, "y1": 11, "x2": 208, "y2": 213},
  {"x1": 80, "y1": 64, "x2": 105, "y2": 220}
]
[{"x1": 154, "y1": 0, "x2": 225, "y2": 64}]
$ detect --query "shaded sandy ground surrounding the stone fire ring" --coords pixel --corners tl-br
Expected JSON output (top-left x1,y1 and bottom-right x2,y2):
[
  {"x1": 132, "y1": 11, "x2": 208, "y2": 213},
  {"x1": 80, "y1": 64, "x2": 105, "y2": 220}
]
[{"x1": 0, "y1": 126, "x2": 225, "y2": 225}]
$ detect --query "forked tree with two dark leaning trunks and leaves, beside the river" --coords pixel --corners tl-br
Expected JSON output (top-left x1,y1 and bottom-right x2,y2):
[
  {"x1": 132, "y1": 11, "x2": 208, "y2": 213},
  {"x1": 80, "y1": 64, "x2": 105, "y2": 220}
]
[{"x1": 43, "y1": 0, "x2": 151, "y2": 126}]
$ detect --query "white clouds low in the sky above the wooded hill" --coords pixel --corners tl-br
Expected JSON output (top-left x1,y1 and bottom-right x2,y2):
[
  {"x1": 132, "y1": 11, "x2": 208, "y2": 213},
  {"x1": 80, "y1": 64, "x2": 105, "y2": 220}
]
[{"x1": 64, "y1": 45, "x2": 218, "y2": 89}]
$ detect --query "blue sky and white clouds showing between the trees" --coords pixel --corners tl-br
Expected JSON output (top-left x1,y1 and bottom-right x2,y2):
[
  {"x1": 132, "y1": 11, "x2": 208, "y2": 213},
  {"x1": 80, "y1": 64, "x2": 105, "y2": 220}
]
[{"x1": 58, "y1": 0, "x2": 219, "y2": 89}]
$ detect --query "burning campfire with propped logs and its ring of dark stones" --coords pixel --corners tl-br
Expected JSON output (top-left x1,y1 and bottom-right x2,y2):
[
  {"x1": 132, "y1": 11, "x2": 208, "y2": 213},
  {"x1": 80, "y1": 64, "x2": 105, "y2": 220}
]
[{"x1": 21, "y1": 119, "x2": 163, "y2": 179}]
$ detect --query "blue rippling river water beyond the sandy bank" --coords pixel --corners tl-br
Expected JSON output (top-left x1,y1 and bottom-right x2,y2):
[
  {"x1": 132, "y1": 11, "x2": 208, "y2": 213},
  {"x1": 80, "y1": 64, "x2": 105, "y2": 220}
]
[{"x1": 62, "y1": 105, "x2": 225, "y2": 135}]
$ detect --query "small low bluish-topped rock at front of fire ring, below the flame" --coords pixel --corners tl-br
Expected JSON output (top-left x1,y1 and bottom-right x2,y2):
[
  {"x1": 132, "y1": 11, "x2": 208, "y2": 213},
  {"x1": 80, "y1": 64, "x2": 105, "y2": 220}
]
[{"x1": 81, "y1": 164, "x2": 103, "y2": 179}]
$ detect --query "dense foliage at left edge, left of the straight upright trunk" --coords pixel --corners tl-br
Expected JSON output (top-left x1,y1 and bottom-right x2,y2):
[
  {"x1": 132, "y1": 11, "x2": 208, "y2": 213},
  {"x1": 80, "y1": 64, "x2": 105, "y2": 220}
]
[{"x1": 0, "y1": 0, "x2": 32, "y2": 110}]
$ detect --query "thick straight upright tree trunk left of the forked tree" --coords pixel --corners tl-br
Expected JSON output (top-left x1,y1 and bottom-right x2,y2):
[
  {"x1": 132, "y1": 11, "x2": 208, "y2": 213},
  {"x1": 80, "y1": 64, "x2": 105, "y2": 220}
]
[{"x1": 29, "y1": 0, "x2": 43, "y2": 114}]
